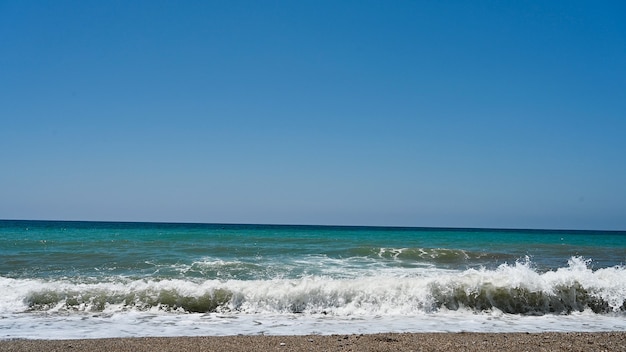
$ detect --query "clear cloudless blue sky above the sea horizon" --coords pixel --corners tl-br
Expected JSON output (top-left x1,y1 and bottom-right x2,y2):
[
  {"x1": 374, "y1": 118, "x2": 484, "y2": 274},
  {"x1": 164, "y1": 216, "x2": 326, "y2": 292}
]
[{"x1": 0, "y1": 0, "x2": 626, "y2": 230}]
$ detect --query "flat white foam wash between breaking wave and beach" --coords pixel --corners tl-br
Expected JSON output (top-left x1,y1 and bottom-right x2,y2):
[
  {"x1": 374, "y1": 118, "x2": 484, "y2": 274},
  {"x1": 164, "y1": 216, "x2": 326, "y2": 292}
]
[{"x1": 0, "y1": 311, "x2": 626, "y2": 339}]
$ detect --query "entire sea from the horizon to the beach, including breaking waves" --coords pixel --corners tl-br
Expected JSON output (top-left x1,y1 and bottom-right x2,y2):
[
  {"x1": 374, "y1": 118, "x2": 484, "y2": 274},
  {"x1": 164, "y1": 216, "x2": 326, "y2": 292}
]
[{"x1": 0, "y1": 221, "x2": 626, "y2": 339}]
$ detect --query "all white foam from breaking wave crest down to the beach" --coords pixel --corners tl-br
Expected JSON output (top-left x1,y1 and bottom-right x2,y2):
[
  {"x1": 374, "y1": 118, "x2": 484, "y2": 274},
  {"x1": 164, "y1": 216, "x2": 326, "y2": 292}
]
[{"x1": 0, "y1": 257, "x2": 626, "y2": 338}]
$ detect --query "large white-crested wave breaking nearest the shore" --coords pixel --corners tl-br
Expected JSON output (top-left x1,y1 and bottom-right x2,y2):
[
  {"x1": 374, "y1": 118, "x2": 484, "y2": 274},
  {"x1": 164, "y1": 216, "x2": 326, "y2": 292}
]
[{"x1": 0, "y1": 257, "x2": 626, "y2": 316}]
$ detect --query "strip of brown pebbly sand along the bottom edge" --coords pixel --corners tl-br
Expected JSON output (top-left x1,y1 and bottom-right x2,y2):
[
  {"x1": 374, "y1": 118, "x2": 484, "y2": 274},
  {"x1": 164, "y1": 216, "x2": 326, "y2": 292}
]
[{"x1": 0, "y1": 332, "x2": 626, "y2": 352}]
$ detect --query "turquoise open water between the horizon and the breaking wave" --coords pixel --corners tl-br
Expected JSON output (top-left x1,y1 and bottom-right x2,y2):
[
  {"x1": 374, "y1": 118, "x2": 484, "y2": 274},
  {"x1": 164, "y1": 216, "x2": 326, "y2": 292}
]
[{"x1": 0, "y1": 221, "x2": 626, "y2": 280}]
